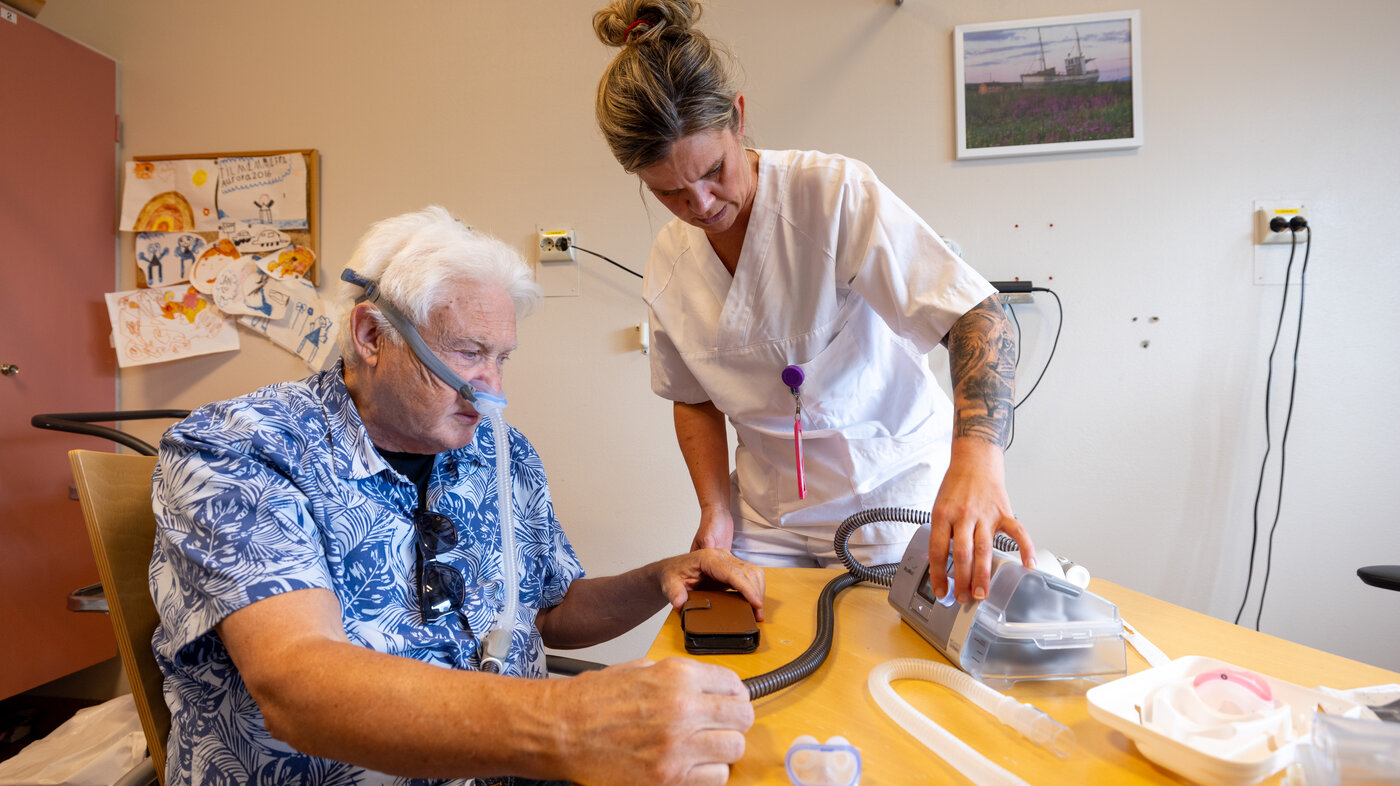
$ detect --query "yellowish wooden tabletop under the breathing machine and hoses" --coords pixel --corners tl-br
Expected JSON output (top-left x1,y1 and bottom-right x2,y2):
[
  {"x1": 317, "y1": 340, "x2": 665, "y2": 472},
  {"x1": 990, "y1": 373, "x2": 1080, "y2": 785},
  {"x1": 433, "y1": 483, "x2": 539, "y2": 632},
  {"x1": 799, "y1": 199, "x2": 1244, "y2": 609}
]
[{"x1": 647, "y1": 567, "x2": 1400, "y2": 786}]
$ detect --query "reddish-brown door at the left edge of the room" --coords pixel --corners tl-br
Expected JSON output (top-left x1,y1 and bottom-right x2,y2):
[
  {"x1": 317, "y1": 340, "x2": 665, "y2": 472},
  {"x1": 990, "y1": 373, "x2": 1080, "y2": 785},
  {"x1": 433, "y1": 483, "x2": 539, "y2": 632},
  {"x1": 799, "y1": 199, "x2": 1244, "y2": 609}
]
[{"x1": 0, "y1": 7, "x2": 116, "y2": 696}]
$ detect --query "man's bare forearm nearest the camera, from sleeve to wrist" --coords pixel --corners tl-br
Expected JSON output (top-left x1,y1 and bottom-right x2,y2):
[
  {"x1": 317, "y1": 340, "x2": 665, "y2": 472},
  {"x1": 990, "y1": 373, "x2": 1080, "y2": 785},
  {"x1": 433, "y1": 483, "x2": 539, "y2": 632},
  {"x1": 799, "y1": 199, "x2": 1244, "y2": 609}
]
[{"x1": 218, "y1": 590, "x2": 567, "y2": 778}]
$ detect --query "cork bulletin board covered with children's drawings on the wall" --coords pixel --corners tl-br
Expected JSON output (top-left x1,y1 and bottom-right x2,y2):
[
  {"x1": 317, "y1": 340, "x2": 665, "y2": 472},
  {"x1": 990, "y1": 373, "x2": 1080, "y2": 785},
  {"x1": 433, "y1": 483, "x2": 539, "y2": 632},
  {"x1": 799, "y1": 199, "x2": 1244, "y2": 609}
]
[{"x1": 105, "y1": 150, "x2": 336, "y2": 370}]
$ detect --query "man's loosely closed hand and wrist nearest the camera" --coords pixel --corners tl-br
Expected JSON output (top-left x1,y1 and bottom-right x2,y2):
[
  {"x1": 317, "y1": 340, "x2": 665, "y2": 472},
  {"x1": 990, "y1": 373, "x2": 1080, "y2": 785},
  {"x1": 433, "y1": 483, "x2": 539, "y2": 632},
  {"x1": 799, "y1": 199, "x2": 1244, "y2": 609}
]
[{"x1": 547, "y1": 659, "x2": 753, "y2": 786}]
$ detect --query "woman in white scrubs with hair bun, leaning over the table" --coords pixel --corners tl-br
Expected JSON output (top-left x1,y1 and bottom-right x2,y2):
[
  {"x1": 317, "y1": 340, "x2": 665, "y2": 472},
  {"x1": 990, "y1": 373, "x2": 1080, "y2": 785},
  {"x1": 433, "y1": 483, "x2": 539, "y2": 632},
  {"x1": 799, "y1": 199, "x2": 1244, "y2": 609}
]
[{"x1": 594, "y1": 0, "x2": 1035, "y2": 602}]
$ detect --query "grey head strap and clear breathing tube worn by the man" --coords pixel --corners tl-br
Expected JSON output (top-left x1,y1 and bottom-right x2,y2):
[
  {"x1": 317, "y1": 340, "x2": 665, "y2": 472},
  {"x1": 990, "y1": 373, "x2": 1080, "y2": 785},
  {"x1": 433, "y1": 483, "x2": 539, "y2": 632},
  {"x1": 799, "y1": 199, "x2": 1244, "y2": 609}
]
[{"x1": 340, "y1": 268, "x2": 519, "y2": 674}]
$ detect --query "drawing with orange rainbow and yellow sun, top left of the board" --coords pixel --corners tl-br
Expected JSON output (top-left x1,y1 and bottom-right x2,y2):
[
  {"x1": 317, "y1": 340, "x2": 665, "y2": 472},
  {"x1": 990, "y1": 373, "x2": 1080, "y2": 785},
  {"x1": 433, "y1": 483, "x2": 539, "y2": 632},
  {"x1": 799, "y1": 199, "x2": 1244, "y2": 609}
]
[{"x1": 118, "y1": 158, "x2": 218, "y2": 233}]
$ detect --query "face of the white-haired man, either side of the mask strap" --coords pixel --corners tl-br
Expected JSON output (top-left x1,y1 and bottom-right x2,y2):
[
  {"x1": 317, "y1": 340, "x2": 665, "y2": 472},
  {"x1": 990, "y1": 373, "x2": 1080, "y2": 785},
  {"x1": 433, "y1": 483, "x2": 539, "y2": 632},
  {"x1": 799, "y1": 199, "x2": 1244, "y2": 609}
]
[{"x1": 356, "y1": 283, "x2": 515, "y2": 454}]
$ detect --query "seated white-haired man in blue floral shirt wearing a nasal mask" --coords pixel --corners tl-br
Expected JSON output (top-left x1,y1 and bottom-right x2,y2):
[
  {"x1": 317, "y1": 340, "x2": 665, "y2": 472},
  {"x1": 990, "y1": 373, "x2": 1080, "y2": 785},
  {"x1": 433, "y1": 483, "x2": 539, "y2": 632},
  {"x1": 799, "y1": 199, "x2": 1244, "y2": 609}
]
[{"x1": 151, "y1": 207, "x2": 763, "y2": 785}]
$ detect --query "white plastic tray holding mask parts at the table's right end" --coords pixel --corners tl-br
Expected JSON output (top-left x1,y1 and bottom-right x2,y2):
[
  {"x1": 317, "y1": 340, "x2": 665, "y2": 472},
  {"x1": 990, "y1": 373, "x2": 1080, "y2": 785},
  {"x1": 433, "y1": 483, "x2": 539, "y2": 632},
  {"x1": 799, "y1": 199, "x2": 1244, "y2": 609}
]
[{"x1": 1085, "y1": 656, "x2": 1365, "y2": 786}]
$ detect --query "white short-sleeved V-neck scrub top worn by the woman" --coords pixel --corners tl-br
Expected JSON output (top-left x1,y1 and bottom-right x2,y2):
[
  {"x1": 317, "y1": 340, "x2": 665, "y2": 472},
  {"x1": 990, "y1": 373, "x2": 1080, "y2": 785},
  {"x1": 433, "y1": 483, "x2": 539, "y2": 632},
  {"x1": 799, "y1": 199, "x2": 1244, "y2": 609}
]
[{"x1": 644, "y1": 150, "x2": 995, "y2": 559}]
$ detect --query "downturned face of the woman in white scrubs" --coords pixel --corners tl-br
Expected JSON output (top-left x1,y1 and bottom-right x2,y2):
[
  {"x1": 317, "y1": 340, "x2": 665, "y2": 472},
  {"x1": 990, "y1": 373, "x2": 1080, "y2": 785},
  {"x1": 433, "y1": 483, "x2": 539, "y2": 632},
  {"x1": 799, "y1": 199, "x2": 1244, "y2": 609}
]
[{"x1": 637, "y1": 123, "x2": 755, "y2": 234}]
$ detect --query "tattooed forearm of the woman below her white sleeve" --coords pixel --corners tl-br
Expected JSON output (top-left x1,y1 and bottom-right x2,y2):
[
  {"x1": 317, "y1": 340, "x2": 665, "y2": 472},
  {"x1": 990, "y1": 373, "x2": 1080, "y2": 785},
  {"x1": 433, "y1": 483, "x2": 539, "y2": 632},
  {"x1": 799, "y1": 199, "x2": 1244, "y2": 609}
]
[{"x1": 944, "y1": 296, "x2": 1016, "y2": 447}]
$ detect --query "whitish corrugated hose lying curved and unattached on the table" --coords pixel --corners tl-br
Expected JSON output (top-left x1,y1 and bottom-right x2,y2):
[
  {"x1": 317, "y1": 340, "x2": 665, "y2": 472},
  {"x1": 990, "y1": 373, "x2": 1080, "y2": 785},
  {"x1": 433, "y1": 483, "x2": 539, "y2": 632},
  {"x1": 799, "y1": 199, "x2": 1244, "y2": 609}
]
[{"x1": 867, "y1": 657, "x2": 1075, "y2": 786}]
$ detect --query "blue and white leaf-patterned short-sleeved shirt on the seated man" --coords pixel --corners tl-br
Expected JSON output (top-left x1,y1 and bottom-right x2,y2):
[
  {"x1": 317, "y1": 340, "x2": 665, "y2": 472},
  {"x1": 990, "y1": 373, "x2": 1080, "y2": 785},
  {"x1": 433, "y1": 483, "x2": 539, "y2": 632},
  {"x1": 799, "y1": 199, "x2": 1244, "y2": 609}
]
[{"x1": 150, "y1": 363, "x2": 582, "y2": 785}]
